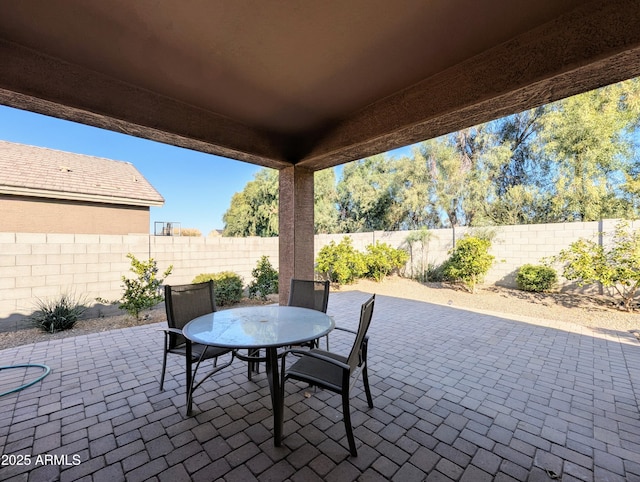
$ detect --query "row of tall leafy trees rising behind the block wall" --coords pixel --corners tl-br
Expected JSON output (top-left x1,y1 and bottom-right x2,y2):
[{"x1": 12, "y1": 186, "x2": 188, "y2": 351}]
[{"x1": 224, "y1": 78, "x2": 640, "y2": 231}]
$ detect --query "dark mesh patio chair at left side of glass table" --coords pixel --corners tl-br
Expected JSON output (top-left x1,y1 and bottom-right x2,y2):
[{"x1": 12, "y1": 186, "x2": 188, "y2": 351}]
[{"x1": 160, "y1": 281, "x2": 234, "y2": 414}]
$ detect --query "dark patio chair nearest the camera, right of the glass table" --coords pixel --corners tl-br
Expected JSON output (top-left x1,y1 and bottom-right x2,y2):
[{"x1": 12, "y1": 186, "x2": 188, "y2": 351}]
[{"x1": 281, "y1": 295, "x2": 375, "y2": 457}]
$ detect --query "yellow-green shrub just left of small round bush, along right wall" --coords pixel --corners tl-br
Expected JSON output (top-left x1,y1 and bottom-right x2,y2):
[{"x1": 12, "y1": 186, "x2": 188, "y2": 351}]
[{"x1": 443, "y1": 236, "x2": 495, "y2": 293}]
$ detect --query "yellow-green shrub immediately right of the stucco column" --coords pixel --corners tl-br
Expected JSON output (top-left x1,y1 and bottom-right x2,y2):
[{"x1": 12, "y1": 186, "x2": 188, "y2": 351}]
[{"x1": 316, "y1": 236, "x2": 367, "y2": 284}]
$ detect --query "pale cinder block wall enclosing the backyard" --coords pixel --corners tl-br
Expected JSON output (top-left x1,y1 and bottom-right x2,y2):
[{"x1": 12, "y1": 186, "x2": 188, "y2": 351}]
[{"x1": 0, "y1": 220, "x2": 639, "y2": 331}]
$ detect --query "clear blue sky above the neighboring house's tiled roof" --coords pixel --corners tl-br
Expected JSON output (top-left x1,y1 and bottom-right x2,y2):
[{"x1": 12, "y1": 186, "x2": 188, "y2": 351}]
[{"x1": 0, "y1": 106, "x2": 410, "y2": 236}]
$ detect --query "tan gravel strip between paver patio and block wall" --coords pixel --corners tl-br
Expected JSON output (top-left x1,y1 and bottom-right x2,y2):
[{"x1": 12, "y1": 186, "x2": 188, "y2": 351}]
[{"x1": 0, "y1": 277, "x2": 640, "y2": 349}]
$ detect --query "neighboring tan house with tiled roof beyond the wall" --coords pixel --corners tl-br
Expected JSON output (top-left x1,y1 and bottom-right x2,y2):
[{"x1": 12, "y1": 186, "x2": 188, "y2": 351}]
[{"x1": 0, "y1": 141, "x2": 164, "y2": 234}]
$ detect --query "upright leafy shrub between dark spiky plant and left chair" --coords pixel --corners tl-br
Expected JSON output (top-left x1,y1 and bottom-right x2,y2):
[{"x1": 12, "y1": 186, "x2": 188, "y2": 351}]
[{"x1": 120, "y1": 253, "x2": 173, "y2": 319}]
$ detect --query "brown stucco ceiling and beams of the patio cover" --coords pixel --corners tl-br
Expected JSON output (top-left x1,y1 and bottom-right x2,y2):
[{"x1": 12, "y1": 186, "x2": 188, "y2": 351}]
[{"x1": 0, "y1": 0, "x2": 640, "y2": 170}]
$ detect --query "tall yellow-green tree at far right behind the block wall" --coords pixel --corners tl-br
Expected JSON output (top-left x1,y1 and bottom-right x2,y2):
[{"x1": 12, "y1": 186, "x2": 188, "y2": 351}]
[{"x1": 540, "y1": 79, "x2": 640, "y2": 221}]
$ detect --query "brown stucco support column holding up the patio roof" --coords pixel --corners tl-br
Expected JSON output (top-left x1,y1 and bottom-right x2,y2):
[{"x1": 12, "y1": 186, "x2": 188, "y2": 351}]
[{"x1": 278, "y1": 166, "x2": 314, "y2": 305}]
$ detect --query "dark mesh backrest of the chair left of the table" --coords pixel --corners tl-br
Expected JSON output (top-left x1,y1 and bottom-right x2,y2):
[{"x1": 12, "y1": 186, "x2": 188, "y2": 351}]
[{"x1": 164, "y1": 280, "x2": 216, "y2": 348}]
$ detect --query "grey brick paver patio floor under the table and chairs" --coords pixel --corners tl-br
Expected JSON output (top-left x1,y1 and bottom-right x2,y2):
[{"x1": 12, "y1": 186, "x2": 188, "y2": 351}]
[{"x1": 0, "y1": 292, "x2": 640, "y2": 482}]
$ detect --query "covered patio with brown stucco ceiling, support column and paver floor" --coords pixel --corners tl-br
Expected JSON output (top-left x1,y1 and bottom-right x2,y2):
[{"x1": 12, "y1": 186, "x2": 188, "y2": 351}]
[{"x1": 0, "y1": 0, "x2": 640, "y2": 482}]
